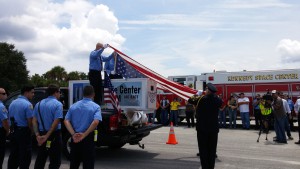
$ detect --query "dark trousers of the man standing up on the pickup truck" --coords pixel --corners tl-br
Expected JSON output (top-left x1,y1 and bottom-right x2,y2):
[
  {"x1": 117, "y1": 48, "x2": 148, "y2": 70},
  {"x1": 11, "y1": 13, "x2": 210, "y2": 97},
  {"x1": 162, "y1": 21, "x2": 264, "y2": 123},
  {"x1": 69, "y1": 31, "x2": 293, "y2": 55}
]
[{"x1": 89, "y1": 70, "x2": 103, "y2": 105}]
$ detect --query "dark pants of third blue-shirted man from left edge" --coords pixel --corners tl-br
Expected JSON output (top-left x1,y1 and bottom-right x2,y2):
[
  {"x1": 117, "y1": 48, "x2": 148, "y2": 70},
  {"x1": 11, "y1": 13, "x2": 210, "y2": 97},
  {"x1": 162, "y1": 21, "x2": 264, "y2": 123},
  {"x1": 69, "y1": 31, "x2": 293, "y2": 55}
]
[{"x1": 34, "y1": 131, "x2": 61, "y2": 169}]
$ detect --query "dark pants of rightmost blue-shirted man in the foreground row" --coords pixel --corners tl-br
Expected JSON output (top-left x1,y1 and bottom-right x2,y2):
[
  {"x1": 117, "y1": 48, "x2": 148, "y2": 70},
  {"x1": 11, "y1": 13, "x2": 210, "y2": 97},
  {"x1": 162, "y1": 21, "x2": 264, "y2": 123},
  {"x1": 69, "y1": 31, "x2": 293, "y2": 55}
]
[{"x1": 70, "y1": 132, "x2": 95, "y2": 169}]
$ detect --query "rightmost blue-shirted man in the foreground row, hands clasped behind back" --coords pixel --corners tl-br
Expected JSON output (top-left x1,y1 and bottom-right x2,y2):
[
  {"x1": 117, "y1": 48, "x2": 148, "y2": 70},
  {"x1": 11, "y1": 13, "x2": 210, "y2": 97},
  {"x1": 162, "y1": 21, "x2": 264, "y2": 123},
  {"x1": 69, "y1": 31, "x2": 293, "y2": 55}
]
[{"x1": 64, "y1": 86, "x2": 102, "y2": 169}]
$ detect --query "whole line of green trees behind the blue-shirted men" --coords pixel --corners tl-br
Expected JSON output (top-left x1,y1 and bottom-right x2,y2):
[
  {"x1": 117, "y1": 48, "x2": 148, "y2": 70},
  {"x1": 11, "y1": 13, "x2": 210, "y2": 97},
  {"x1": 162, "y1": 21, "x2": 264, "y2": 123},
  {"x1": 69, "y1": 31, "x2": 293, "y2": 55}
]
[{"x1": 0, "y1": 42, "x2": 88, "y2": 92}]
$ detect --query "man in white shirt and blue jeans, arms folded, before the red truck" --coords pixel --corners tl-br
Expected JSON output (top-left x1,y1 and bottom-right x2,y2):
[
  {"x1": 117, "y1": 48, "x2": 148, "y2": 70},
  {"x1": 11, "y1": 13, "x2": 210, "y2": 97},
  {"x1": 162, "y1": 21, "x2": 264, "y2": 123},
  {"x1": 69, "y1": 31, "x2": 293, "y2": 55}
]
[{"x1": 238, "y1": 93, "x2": 250, "y2": 130}]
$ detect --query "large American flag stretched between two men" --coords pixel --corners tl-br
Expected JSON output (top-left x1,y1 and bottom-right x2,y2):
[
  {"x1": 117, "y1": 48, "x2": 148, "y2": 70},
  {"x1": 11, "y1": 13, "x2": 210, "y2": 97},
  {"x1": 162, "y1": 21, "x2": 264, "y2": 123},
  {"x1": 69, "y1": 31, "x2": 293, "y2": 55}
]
[{"x1": 110, "y1": 46, "x2": 197, "y2": 100}]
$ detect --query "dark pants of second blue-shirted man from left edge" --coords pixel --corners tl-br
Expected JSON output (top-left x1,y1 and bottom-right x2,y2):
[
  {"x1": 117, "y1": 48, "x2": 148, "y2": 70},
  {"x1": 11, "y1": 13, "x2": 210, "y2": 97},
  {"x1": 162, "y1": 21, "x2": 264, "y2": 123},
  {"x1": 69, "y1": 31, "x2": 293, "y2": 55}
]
[{"x1": 7, "y1": 127, "x2": 32, "y2": 169}]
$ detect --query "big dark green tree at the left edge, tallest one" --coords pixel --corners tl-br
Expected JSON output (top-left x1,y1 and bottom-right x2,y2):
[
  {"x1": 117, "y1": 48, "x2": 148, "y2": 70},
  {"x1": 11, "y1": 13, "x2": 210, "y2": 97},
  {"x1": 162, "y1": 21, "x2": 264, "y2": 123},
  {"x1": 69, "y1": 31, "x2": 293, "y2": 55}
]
[{"x1": 0, "y1": 42, "x2": 28, "y2": 91}]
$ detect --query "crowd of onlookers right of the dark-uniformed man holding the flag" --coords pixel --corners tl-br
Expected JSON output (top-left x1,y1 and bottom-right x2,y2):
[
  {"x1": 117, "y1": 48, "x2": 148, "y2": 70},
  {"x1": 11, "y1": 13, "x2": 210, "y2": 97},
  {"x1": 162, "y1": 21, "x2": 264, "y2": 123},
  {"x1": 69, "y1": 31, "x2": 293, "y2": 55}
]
[{"x1": 214, "y1": 90, "x2": 300, "y2": 144}]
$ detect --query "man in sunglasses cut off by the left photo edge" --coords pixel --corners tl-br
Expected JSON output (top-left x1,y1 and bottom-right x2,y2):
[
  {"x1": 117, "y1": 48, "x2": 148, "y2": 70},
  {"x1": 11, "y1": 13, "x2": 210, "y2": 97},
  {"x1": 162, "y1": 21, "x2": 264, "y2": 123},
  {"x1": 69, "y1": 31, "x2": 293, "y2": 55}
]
[{"x1": 0, "y1": 87, "x2": 9, "y2": 169}]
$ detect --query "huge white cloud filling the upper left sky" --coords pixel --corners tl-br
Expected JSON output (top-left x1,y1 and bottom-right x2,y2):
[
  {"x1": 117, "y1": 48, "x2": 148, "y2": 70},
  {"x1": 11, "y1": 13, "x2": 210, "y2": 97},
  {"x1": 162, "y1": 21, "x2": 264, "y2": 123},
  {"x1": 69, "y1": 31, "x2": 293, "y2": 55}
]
[{"x1": 0, "y1": 0, "x2": 125, "y2": 74}]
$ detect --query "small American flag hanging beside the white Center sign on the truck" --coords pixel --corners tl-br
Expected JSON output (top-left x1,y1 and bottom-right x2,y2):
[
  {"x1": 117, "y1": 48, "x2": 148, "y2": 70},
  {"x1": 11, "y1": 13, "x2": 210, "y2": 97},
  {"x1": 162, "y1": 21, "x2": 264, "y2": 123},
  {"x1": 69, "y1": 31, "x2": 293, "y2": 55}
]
[{"x1": 104, "y1": 71, "x2": 122, "y2": 115}]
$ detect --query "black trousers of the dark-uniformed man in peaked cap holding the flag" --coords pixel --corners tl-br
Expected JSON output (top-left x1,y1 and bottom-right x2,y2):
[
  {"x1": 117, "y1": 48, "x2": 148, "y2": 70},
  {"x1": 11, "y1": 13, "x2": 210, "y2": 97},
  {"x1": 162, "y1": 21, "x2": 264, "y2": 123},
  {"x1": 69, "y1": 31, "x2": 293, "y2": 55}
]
[{"x1": 197, "y1": 131, "x2": 218, "y2": 169}]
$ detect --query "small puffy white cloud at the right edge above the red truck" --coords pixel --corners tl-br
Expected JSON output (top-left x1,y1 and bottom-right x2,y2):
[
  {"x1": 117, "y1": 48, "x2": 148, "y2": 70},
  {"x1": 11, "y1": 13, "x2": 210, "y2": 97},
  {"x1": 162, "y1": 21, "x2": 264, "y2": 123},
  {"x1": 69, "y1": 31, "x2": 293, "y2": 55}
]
[{"x1": 277, "y1": 39, "x2": 300, "y2": 63}]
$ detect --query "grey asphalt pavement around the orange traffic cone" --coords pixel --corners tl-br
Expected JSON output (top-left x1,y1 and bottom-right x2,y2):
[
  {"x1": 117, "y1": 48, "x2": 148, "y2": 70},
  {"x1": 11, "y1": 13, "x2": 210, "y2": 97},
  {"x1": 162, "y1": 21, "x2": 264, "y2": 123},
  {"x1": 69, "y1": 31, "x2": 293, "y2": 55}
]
[{"x1": 3, "y1": 125, "x2": 300, "y2": 169}]
